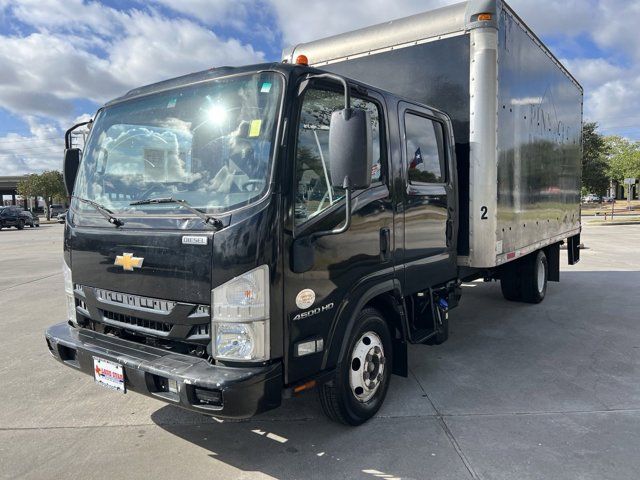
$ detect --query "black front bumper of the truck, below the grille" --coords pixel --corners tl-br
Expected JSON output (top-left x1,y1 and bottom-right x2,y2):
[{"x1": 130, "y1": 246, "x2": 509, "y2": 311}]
[{"x1": 45, "y1": 323, "x2": 283, "y2": 418}]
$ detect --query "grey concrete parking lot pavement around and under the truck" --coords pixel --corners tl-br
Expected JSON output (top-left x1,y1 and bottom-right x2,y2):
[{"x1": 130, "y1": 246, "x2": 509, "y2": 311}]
[{"x1": 0, "y1": 225, "x2": 640, "y2": 480}]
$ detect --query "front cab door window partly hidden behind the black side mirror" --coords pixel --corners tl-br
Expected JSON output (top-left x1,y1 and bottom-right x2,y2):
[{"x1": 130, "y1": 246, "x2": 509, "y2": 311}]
[{"x1": 295, "y1": 89, "x2": 382, "y2": 225}]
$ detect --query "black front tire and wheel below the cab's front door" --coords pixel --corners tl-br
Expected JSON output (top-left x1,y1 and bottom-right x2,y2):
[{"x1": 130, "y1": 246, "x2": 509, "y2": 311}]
[{"x1": 318, "y1": 308, "x2": 393, "y2": 426}]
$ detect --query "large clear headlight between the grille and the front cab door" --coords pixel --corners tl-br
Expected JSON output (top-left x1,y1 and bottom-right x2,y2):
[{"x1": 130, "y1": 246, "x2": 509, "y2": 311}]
[{"x1": 211, "y1": 265, "x2": 270, "y2": 361}]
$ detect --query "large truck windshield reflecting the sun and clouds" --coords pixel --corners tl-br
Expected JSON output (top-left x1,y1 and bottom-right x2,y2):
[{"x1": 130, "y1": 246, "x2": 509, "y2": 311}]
[{"x1": 74, "y1": 72, "x2": 283, "y2": 215}]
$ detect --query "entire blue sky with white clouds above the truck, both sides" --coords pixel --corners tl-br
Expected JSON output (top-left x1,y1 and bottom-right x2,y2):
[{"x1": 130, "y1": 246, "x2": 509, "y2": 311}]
[{"x1": 0, "y1": 0, "x2": 640, "y2": 175}]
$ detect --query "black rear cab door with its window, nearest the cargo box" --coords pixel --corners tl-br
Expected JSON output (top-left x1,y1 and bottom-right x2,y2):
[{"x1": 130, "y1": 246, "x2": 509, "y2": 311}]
[{"x1": 398, "y1": 102, "x2": 457, "y2": 295}]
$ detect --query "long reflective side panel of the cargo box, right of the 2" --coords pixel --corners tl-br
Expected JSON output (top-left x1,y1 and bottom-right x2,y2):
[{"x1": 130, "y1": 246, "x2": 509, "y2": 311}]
[{"x1": 496, "y1": 8, "x2": 582, "y2": 263}]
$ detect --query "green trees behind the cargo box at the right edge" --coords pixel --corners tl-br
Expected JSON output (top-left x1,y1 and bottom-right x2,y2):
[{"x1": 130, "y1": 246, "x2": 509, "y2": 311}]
[{"x1": 582, "y1": 122, "x2": 640, "y2": 195}]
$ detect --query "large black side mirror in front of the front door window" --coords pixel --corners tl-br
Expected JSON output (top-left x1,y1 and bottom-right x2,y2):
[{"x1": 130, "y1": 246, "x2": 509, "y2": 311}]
[{"x1": 329, "y1": 107, "x2": 373, "y2": 190}]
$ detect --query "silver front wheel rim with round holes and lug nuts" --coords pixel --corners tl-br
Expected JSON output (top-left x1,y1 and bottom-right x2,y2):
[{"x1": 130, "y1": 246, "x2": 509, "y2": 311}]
[{"x1": 349, "y1": 332, "x2": 386, "y2": 403}]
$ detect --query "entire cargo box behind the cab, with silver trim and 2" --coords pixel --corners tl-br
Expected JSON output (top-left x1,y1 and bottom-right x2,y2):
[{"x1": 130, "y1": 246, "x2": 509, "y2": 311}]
[{"x1": 283, "y1": 0, "x2": 582, "y2": 268}]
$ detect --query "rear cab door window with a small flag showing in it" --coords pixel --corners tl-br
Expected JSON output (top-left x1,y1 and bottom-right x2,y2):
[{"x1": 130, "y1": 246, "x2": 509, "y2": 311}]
[{"x1": 404, "y1": 112, "x2": 446, "y2": 184}]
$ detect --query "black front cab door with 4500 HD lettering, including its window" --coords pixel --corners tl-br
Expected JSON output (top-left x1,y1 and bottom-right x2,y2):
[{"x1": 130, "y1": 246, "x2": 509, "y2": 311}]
[{"x1": 283, "y1": 82, "x2": 394, "y2": 383}]
